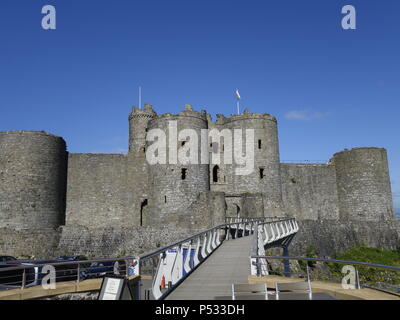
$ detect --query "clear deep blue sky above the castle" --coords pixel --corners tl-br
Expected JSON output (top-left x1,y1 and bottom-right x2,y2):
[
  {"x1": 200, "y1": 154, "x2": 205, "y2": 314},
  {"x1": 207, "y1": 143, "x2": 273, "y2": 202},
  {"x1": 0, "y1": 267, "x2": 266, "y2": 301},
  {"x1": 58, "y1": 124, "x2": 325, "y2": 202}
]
[{"x1": 0, "y1": 0, "x2": 400, "y2": 211}]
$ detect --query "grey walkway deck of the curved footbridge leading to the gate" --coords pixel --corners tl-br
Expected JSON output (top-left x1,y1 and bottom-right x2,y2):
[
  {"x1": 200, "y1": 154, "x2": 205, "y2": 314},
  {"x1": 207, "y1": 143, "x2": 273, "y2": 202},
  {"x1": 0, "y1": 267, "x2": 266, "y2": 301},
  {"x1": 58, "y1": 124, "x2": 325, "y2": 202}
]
[{"x1": 167, "y1": 236, "x2": 253, "y2": 300}]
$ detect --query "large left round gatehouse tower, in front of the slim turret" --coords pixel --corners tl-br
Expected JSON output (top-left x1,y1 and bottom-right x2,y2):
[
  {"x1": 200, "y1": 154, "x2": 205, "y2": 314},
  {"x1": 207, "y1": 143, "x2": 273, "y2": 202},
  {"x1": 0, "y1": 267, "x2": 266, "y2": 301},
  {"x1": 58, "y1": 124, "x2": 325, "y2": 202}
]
[{"x1": 147, "y1": 105, "x2": 209, "y2": 224}]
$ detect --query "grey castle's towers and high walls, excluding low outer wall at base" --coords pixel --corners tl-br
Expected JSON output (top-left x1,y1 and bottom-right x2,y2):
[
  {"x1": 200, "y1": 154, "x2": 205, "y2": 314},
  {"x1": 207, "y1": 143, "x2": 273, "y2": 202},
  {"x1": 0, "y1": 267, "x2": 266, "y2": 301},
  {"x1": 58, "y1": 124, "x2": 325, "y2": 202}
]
[{"x1": 0, "y1": 105, "x2": 394, "y2": 235}]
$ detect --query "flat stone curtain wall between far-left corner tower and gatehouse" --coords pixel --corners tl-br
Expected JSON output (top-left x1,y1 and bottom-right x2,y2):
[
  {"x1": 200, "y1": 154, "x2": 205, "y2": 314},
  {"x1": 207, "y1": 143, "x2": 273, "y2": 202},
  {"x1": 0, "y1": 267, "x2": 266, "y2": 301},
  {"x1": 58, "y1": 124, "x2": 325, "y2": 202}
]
[{"x1": 66, "y1": 154, "x2": 135, "y2": 228}]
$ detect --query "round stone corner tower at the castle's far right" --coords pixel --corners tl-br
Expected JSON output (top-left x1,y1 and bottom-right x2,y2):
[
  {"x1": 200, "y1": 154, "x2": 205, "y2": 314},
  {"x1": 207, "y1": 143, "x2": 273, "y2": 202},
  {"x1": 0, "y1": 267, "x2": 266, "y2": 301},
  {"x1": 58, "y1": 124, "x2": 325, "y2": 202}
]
[{"x1": 331, "y1": 148, "x2": 394, "y2": 221}]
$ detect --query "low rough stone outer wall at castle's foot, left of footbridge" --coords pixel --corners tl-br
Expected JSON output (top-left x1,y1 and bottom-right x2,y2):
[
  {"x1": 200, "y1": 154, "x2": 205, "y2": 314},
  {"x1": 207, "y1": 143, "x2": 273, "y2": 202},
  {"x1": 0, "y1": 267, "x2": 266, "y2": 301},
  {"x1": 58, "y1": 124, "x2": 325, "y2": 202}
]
[{"x1": 0, "y1": 226, "x2": 199, "y2": 260}]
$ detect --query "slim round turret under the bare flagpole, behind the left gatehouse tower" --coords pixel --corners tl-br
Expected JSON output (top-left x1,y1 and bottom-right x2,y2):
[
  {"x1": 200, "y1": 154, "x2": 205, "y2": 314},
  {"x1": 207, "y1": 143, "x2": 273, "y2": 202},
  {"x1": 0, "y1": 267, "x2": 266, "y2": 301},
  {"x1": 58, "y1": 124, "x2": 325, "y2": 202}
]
[{"x1": 129, "y1": 104, "x2": 156, "y2": 153}]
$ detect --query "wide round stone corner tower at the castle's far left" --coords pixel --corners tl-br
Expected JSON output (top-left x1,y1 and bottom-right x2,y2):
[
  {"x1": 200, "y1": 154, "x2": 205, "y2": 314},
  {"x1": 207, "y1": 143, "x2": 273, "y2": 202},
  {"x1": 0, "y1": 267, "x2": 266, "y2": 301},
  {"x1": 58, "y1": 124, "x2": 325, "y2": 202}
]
[{"x1": 0, "y1": 131, "x2": 67, "y2": 229}]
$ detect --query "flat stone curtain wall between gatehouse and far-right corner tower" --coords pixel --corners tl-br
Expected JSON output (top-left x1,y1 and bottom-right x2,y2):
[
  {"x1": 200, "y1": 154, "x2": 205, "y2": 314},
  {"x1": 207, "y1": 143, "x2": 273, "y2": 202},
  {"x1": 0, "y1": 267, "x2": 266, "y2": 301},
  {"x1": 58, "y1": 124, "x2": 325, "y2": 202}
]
[{"x1": 281, "y1": 164, "x2": 339, "y2": 220}]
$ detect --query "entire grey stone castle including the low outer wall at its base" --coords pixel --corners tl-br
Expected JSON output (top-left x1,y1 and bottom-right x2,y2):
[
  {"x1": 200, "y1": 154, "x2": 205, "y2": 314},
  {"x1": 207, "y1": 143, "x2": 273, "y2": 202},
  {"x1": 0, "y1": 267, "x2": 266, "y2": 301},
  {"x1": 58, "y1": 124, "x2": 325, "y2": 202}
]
[{"x1": 0, "y1": 105, "x2": 400, "y2": 258}]
